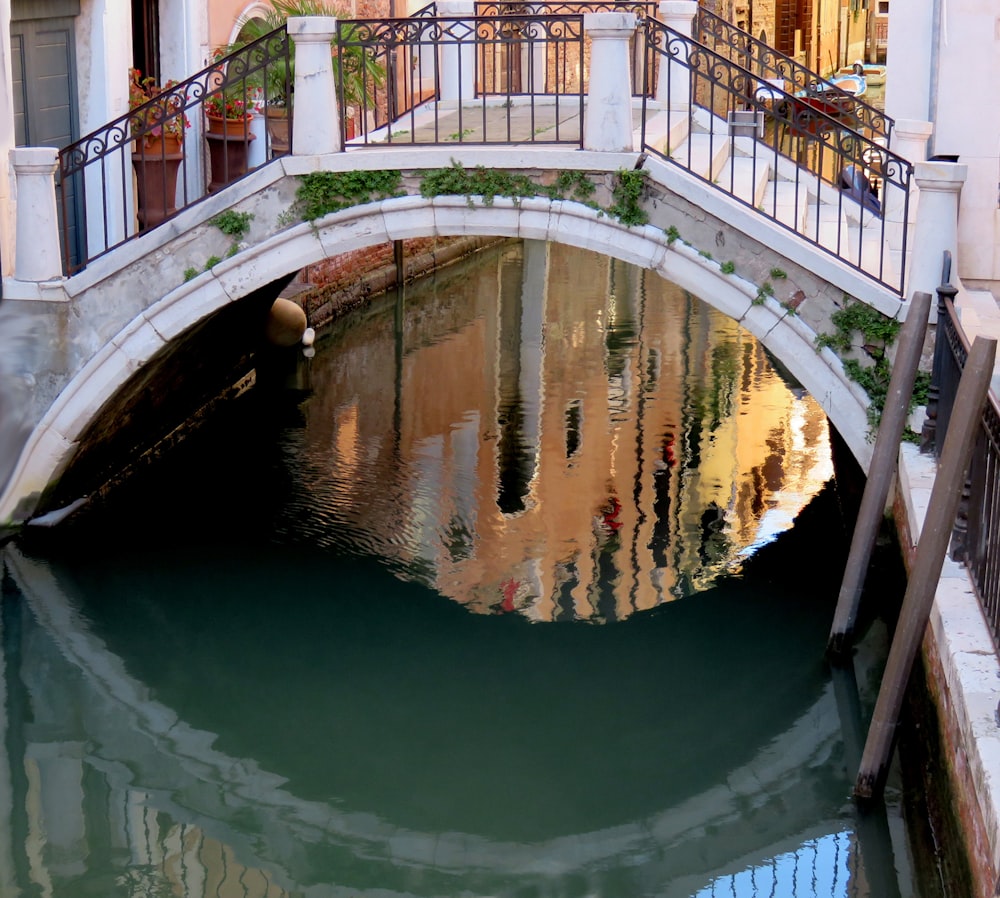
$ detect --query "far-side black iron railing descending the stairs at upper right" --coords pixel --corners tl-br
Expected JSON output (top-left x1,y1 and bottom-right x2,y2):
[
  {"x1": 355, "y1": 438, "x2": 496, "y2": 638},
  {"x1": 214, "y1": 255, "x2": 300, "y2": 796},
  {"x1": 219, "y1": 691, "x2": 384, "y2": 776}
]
[{"x1": 694, "y1": 6, "x2": 894, "y2": 144}]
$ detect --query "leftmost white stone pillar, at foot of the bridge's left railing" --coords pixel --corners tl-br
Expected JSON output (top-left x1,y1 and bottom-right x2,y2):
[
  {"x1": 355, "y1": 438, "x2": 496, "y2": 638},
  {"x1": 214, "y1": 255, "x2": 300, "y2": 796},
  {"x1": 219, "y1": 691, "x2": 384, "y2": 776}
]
[{"x1": 10, "y1": 147, "x2": 63, "y2": 281}]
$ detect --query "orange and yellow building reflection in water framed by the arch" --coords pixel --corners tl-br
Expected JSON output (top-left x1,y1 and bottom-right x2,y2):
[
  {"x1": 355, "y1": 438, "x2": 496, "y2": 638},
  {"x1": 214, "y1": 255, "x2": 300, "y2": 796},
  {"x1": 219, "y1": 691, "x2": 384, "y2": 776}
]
[{"x1": 287, "y1": 241, "x2": 832, "y2": 621}]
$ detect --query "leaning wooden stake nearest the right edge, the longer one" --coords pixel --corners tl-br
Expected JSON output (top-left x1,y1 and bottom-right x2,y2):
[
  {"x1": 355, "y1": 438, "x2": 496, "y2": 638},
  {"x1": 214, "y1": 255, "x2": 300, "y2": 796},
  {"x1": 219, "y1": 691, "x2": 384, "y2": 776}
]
[{"x1": 854, "y1": 337, "x2": 997, "y2": 798}]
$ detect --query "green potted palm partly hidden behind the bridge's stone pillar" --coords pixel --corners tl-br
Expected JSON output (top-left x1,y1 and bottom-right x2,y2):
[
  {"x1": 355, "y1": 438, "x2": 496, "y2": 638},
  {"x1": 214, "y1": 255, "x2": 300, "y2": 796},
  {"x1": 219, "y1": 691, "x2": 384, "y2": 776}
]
[{"x1": 229, "y1": 0, "x2": 385, "y2": 154}]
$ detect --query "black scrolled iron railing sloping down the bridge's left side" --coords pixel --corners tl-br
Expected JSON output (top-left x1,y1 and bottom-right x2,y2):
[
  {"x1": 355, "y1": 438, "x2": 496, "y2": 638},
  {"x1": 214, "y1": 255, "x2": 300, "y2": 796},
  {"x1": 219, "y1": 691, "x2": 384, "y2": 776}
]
[{"x1": 57, "y1": 27, "x2": 292, "y2": 274}]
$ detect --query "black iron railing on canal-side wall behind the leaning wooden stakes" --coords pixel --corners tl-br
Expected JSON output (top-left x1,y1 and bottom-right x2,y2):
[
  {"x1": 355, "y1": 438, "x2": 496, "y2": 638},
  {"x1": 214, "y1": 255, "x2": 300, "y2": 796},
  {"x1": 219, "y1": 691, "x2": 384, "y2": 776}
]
[{"x1": 920, "y1": 252, "x2": 1000, "y2": 652}]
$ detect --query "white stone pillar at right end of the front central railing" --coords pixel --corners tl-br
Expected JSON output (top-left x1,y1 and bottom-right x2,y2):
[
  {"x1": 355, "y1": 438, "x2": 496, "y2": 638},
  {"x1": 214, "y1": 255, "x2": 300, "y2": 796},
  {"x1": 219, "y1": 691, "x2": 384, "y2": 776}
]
[{"x1": 583, "y1": 12, "x2": 635, "y2": 153}]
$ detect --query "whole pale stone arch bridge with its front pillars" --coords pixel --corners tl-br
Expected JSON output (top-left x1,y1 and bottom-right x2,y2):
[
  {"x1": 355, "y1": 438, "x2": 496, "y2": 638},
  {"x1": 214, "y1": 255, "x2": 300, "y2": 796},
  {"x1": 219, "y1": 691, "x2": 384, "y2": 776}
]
[{"x1": 0, "y1": 10, "x2": 961, "y2": 527}]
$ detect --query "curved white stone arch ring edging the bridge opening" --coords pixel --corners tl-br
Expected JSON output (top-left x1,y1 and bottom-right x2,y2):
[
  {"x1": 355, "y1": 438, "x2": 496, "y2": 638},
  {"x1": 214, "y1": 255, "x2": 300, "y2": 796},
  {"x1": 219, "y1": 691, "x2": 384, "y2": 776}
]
[{"x1": 0, "y1": 178, "x2": 871, "y2": 521}]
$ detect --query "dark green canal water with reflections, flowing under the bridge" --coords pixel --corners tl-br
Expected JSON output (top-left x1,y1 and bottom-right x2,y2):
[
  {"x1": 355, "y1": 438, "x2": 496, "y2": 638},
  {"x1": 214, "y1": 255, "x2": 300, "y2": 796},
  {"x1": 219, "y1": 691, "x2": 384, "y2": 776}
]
[{"x1": 0, "y1": 242, "x2": 943, "y2": 898}]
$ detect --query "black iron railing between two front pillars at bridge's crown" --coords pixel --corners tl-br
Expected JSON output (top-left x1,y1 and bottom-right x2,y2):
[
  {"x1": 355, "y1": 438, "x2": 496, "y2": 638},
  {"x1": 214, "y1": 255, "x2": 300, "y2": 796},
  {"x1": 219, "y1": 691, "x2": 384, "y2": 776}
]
[{"x1": 335, "y1": 15, "x2": 586, "y2": 146}]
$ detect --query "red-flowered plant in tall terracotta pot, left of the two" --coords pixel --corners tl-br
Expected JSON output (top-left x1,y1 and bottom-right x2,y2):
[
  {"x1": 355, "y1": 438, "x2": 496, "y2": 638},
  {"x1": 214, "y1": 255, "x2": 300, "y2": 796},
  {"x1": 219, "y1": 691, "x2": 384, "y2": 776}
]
[{"x1": 128, "y1": 69, "x2": 191, "y2": 230}]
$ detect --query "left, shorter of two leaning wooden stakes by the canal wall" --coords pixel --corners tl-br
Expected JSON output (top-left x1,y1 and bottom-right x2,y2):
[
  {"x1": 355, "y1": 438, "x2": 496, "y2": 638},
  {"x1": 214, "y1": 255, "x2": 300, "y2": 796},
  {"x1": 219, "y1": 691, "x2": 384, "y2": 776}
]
[{"x1": 827, "y1": 293, "x2": 931, "y2": 658}]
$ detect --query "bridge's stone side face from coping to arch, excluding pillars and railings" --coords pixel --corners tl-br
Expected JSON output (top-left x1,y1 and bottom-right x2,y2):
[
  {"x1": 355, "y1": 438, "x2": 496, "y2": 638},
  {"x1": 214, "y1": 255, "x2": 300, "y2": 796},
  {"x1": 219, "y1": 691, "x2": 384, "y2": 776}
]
[{"x1": 0, "y1": 148, "x2": 903, "y2": 520}]
